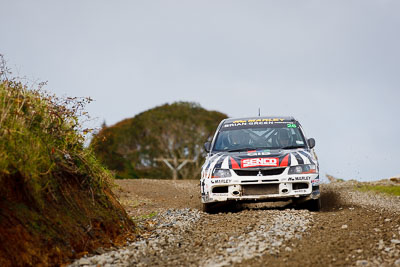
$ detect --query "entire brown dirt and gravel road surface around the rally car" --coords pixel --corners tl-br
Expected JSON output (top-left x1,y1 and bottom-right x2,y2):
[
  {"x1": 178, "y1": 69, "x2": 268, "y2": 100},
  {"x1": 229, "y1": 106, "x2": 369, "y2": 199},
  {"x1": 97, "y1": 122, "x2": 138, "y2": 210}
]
[{"x1": 73, "y1": 179, "x2": 400, "y2": 266}]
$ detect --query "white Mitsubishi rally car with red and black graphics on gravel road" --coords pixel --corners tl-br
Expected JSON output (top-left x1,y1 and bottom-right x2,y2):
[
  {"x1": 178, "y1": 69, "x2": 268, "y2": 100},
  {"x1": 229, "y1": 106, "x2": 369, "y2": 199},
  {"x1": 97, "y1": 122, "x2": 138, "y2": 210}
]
[{"x1": 200, "y1": 117, "x2": 321, "y2": 212}]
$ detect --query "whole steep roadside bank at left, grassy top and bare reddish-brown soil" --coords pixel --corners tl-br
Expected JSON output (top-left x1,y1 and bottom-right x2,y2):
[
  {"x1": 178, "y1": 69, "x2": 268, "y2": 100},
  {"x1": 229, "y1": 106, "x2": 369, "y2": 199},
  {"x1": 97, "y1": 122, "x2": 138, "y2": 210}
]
[{"x1": 0, "y1": 56, "x2": 134, "y2": 266}]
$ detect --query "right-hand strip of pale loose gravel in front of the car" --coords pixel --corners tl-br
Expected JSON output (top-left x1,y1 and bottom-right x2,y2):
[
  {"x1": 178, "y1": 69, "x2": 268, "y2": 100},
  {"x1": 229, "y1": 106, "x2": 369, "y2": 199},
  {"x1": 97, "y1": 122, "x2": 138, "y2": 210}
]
[{"x1": 203, "y1": 210, "x2": 312, "y2": 267}]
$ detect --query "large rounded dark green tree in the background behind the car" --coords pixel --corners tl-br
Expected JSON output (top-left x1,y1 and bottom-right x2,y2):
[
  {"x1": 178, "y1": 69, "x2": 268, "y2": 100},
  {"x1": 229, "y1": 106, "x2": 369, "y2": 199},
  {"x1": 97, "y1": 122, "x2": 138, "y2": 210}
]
[{"x1": 91, "y1": 102, "x2": 226, "y2": 178}]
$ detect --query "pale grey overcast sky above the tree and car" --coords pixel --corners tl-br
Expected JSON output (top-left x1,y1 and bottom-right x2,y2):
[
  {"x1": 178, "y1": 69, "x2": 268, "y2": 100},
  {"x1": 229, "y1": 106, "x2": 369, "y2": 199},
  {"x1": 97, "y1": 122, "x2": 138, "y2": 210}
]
[{"x1": 0, "y1": 0, "x2": 400, "y2": 181}]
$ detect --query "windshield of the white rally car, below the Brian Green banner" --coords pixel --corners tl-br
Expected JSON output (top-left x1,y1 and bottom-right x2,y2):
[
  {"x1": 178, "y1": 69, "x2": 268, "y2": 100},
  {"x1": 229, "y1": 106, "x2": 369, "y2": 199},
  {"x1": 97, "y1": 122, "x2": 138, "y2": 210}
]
[{"x1": 213, "y1": 124, "x2": 305, "y2": 152}]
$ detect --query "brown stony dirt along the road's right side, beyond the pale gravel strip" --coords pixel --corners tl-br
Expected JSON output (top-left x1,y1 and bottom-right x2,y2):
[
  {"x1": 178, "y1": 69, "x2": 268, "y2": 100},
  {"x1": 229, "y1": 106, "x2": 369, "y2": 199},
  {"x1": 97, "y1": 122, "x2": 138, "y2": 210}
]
[{"x1": 242, "y1": 183, "x2": 400, "y2": 266}]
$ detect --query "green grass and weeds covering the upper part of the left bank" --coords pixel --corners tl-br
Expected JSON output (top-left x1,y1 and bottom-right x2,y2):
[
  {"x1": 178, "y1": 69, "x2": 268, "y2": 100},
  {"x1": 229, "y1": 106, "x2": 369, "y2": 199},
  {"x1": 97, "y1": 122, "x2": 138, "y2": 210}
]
[{"x1": 0, "y1": 55, "x2": 112, "y2": 205}]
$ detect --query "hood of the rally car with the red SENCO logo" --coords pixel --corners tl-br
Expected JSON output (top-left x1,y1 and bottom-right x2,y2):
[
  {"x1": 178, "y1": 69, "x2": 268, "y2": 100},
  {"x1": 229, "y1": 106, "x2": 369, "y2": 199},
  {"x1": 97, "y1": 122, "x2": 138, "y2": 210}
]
[{"x1": 204, "y1": 149, "x2": 316, "y2": 171}]
